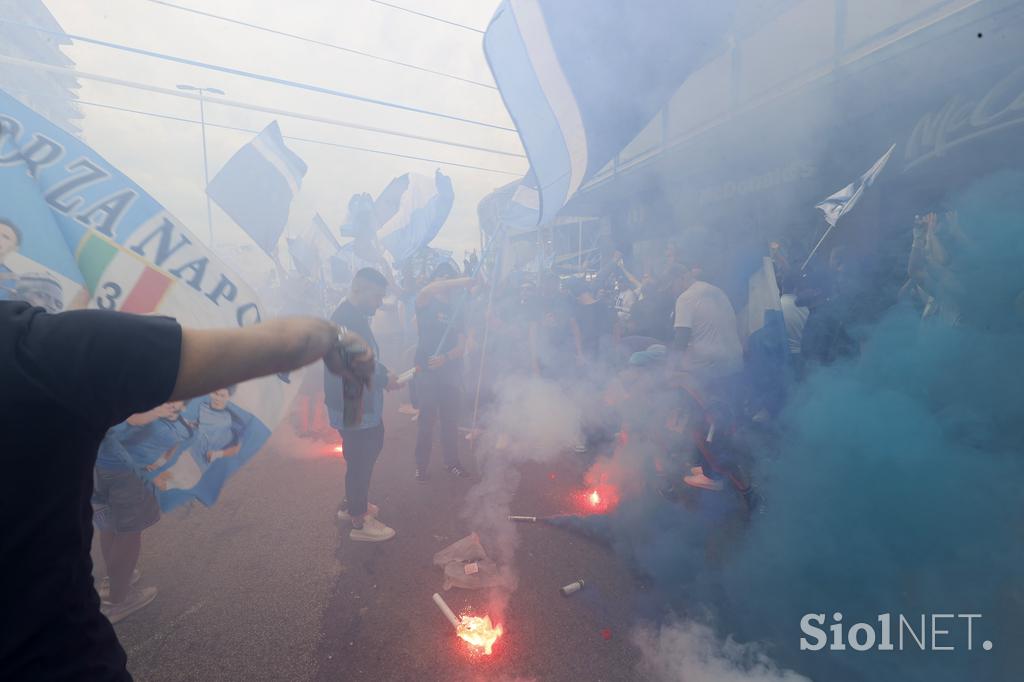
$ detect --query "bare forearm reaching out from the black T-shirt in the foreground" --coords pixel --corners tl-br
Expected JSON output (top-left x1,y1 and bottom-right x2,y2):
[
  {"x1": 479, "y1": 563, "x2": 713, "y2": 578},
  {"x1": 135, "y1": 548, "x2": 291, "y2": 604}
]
[{"x1": 171, "y1": 317, "x2": 338, "y2": 400}]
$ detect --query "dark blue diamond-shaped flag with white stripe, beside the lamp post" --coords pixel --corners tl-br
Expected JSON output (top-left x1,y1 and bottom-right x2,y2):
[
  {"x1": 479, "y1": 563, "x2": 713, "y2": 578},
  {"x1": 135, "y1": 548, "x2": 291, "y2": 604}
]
[{"x1": 206, "y1": 121, "x2": 306, "y2": 254}]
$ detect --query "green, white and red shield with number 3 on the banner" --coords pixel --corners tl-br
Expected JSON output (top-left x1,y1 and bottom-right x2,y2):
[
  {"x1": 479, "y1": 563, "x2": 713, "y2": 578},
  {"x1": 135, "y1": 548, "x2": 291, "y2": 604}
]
[{"x1": 75, "y1": 232, "x2": 174, "y2": 313}]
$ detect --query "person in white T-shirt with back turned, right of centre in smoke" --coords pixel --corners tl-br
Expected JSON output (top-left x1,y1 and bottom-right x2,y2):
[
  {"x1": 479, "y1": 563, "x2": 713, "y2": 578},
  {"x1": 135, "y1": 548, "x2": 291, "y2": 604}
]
[{"x1": 670, "y1": 266, "x2": 750, "y2": 494}]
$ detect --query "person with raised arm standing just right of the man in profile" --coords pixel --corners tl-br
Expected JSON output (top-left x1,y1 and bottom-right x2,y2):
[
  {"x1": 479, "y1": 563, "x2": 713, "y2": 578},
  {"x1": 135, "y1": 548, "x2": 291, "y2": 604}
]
[{"x1": 414, "y1": 263, "x2": 475, "y2": 482}]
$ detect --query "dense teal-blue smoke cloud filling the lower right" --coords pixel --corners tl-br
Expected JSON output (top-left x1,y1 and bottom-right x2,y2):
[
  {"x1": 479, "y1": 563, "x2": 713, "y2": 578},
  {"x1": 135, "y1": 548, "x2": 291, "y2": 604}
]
[{"x1": 562, "y1": 172, "x2": 1024, "y2": 682}]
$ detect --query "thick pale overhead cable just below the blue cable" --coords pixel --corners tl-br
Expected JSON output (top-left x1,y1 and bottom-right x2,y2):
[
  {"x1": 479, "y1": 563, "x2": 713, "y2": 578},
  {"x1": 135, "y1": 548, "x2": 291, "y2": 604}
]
[{"x1": 0, "y1": 53, "x2": 526, "y2": 159}]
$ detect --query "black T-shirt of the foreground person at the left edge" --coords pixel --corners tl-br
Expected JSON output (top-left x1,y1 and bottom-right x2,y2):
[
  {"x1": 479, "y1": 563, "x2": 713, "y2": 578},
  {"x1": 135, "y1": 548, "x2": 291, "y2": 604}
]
[{"x1": 0, "y1": 301, "x2": 181, "y2": 680}]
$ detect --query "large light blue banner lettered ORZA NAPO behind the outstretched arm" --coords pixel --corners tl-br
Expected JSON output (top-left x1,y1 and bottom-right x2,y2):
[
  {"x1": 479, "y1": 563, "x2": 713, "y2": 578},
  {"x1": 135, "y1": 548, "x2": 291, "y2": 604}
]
[{"x1": 0, "y1": 91, "x2": 293, "y2": 510}]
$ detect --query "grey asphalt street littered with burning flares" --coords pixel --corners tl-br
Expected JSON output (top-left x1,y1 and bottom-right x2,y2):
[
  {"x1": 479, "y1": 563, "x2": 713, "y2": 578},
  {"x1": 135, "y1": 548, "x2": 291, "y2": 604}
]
[{"x1": 101, "y1": 393, "x2": 641, "y2": 682}]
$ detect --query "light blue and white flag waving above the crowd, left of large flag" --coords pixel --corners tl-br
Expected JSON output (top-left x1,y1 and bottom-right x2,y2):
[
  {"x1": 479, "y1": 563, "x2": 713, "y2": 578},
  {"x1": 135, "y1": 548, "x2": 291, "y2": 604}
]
[{"x1": 378, "y1": 171, "x2": 455, "y2": 264}]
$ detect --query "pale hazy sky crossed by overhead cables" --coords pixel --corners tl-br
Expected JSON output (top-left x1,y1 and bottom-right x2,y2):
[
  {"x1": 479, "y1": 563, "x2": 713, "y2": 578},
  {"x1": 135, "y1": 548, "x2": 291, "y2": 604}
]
[{"x1": 36, "y1": 0, "x2": 527, "y2": 260}]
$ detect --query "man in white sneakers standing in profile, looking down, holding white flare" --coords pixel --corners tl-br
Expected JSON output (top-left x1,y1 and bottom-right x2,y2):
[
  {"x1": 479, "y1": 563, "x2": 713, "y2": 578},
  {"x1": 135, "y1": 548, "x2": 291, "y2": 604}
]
[{"x1": 324, "y1": 267, "x2": 398, "y2": 542}]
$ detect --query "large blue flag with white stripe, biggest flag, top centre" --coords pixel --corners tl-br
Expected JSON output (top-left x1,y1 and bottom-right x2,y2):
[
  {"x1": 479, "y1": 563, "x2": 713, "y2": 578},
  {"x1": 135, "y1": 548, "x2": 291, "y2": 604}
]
[{"x1": 483, "y1": 0, "x2": 735, "y2": 223}]
